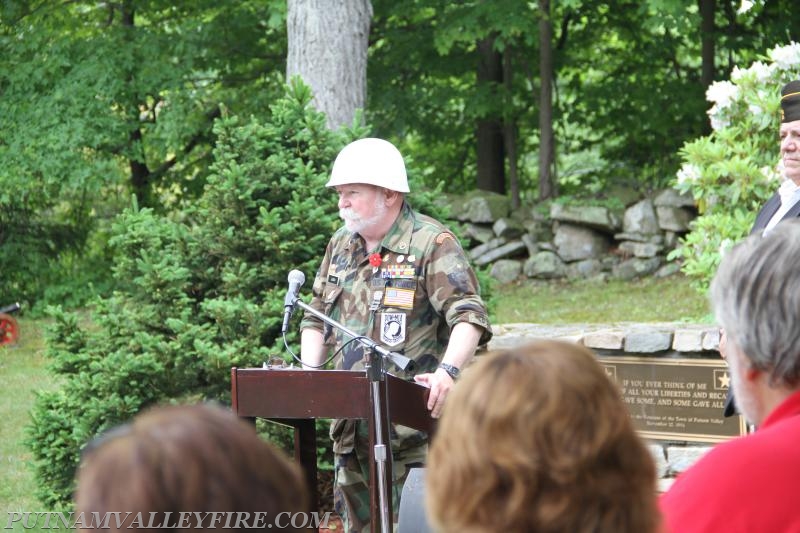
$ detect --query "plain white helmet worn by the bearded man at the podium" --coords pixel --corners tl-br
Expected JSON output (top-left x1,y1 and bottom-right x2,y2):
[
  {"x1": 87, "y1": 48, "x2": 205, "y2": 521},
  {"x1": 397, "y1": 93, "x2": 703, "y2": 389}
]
[{"x1": 325, "y1": 138, "x2": 409, "y2": 192}]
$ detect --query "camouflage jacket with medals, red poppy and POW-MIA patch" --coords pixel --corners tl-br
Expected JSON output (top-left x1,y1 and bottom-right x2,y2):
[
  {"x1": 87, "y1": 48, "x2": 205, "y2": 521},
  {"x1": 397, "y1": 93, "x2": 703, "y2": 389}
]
[{"x1": 300, "y1": 203, "x2": 492, "y2": 453}]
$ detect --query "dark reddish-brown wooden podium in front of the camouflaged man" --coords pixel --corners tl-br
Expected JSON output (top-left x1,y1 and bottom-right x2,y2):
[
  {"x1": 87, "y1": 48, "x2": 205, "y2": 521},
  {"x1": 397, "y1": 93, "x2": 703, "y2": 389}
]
[{"x1": 231, "y1": 367, "x2": 435, "y2": 531}]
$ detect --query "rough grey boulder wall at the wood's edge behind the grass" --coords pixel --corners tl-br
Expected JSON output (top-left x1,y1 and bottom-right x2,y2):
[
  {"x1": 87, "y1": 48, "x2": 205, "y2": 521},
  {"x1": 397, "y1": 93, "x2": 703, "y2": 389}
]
[{"x1": 445, "y1": 189, "x2": 697, "y2": 283}]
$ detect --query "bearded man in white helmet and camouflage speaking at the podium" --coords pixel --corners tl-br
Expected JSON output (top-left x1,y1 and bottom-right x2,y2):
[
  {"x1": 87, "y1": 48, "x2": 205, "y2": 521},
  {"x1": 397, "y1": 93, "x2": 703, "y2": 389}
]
[{"x1": 301, "y1": 139, "x2": 491, "y2": 531}]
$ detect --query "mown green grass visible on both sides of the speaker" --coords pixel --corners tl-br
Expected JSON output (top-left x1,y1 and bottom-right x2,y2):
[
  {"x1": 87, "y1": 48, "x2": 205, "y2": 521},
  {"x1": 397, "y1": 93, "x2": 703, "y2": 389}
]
[{"x1": 0, "y1": 276, "x2": 710, "y2": 516}]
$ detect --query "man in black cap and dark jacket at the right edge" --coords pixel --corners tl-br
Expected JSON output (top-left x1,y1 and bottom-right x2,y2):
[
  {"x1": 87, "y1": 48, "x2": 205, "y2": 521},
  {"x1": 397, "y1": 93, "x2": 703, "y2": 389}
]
[{"x1": 719, "y1": 80, "x2": 800, "y2": 416}]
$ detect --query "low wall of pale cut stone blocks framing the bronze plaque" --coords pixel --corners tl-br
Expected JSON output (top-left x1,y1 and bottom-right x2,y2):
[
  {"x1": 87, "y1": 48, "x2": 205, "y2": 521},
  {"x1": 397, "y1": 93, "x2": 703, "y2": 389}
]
[{"x1": 489, "y1": 323, "x2": 736, "y2": 491}]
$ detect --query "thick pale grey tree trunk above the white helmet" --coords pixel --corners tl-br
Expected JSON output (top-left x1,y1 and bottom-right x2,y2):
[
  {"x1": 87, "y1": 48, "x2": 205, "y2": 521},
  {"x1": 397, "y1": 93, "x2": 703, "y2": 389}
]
[{"x1": 286, "y1": 0, "x2": 372, "y2": 129}]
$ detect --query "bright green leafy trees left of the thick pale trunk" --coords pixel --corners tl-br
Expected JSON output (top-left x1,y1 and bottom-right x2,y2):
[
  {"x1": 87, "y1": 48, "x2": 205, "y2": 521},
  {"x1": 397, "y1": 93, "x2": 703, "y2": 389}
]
[{"x1": 0, "y1": 0, "x2": 285, "y2": 306}]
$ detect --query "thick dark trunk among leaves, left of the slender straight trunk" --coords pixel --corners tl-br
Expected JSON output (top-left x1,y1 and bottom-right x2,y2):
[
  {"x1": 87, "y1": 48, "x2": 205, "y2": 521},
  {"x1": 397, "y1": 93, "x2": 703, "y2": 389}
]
[{"x1": 477, "y1": 36, "x2": 506, "y2": 194}]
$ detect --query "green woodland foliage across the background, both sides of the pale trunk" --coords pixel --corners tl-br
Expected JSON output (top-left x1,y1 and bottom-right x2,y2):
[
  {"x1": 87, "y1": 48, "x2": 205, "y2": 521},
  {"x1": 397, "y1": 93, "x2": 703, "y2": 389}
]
[{"x1": 0, "y1": 0, "x2": 800, "y2": 312}]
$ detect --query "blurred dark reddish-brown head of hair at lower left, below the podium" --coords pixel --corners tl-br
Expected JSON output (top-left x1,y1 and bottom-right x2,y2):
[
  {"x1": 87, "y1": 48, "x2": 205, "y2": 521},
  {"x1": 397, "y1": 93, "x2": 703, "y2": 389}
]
[{"x1": 75, "y1": 405, "x2": 309, "y2": 531}]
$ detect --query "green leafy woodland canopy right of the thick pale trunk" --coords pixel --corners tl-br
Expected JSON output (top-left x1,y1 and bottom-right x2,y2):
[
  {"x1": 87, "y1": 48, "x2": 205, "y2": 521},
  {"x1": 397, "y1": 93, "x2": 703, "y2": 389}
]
[{"x1": 368, "y1": 0, "x2": 800, "y2": 192}]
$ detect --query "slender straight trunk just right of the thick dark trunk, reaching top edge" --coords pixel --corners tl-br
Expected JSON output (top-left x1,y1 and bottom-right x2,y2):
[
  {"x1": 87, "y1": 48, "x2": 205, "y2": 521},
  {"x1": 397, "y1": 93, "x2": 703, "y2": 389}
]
[{"x1": 539, "y1": 0, "x2": 556, "y2": 200}]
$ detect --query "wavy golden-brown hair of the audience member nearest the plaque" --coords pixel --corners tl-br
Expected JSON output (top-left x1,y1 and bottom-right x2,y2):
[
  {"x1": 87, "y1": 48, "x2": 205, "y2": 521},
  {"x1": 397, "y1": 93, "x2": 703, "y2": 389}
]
[{"x1": 426, "y1": 341, "x2": 659, "y2": 533}]
